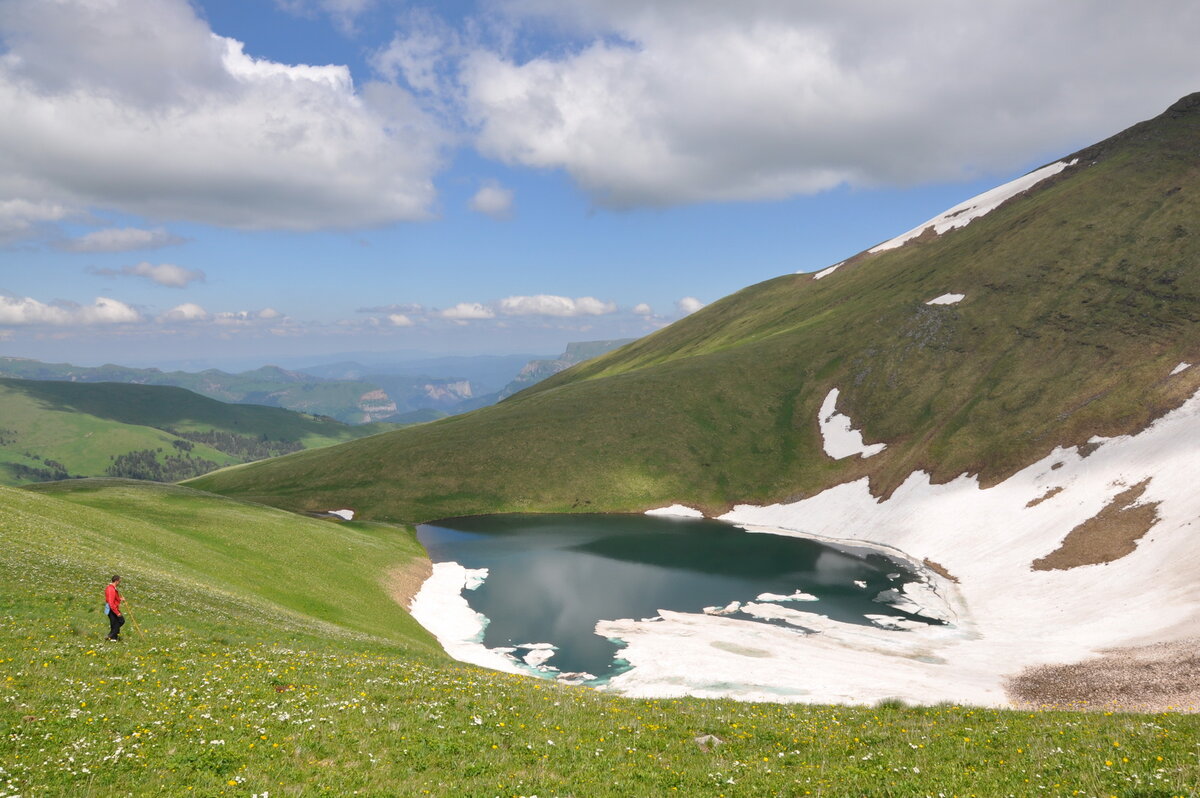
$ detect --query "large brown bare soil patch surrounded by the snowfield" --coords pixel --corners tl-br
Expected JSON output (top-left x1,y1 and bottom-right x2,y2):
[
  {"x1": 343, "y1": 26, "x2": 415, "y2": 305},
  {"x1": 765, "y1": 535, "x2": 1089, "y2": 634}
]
[{"x1": 1031, "y1": 479, "x2": 1158, "y2": 571}]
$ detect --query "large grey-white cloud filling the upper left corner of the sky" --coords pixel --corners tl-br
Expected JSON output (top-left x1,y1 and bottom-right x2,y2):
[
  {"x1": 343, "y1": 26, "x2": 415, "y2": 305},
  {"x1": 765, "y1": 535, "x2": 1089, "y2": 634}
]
[{"x1": 0, "y1": 0, "x2": 445, "y2": 230}]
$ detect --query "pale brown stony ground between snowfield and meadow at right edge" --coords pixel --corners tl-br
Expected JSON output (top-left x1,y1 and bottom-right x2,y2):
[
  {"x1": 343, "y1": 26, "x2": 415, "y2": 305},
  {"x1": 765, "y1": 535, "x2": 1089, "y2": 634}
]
[{"x1": 1006, "y1": 637, "x2": 1200, "y2": 712}]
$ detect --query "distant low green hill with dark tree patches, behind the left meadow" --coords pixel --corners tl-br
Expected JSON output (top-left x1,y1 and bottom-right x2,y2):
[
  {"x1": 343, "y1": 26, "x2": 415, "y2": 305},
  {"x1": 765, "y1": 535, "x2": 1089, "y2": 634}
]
[{"x1": 0, "y1": 379, "x2": 394, "y2": 485}]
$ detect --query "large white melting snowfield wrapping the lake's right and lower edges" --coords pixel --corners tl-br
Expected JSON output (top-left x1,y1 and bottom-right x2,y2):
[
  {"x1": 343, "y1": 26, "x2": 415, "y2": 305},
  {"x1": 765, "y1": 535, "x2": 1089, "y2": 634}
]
[{"x1": 596, "y1": 391, "x2": 1200, "y2": 706}]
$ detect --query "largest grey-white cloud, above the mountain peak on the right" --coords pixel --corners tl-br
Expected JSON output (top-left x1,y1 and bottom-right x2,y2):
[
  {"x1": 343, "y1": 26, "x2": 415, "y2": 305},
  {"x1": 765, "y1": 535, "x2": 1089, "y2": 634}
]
[{"x1": 460, "y1": 0, "x2": 1200, "y2": 206}]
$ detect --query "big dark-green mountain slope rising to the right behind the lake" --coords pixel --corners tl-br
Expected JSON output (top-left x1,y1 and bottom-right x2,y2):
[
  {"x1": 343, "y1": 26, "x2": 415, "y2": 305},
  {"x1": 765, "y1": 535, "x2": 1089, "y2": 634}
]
[{"x1": 194, "y1": 97, "x2": 1200, "y2": 521}]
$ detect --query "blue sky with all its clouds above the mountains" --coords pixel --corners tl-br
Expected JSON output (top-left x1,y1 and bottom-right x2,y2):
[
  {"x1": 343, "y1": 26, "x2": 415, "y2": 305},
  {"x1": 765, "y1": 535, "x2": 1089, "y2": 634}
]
[{"x1": 0, "y1": 0, "x2": 1200, "y2": 367}]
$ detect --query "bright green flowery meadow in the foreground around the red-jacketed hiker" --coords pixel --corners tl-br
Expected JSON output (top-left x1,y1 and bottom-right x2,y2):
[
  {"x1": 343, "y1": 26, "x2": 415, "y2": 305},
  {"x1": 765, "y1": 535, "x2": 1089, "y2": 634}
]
[{"x1": 0, "y1": 480, "x2": 1200, "y2": 796}]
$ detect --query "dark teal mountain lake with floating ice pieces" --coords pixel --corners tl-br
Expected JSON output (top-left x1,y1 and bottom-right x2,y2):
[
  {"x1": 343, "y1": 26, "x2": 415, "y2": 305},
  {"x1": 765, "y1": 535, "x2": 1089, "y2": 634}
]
[{"x1": 418, "y1": 515, "x2": 931, "y2": 683}]
